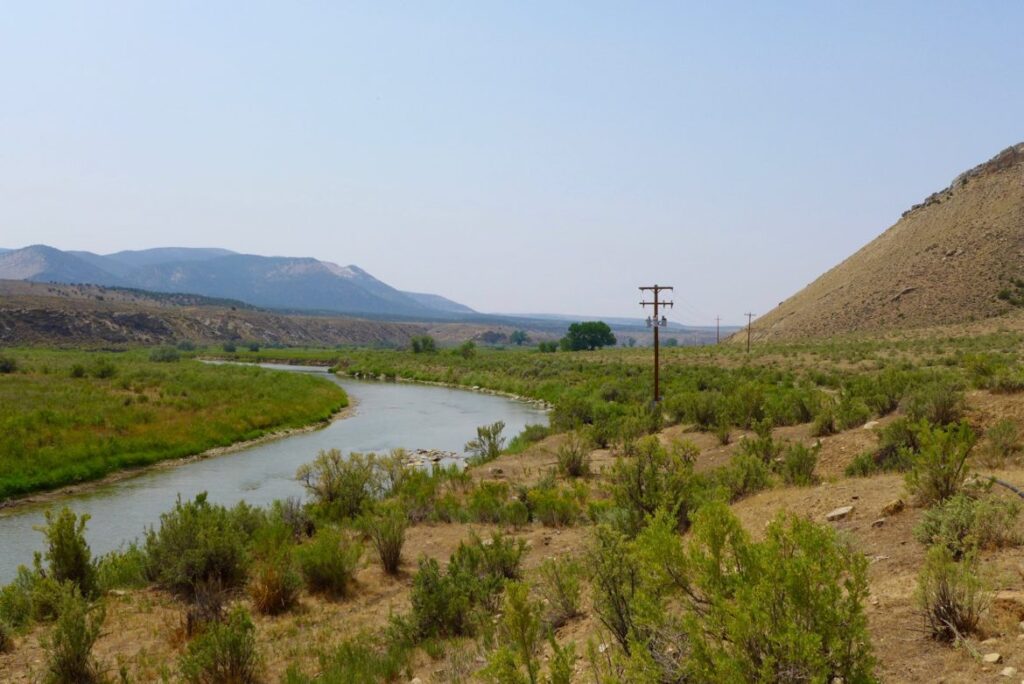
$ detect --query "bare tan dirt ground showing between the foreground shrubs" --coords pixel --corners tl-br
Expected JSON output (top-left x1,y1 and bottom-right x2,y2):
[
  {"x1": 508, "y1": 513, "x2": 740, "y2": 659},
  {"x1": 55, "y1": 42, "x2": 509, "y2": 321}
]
[{"x1": 6, "y1": 392, "x2": 1024, "y2": 683}]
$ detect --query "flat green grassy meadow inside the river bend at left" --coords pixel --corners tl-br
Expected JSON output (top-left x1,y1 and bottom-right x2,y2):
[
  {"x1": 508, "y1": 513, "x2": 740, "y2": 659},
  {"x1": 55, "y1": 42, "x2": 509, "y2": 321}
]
[{"x1": 0, "y1": 349, "x2": 348, "y2": 500}]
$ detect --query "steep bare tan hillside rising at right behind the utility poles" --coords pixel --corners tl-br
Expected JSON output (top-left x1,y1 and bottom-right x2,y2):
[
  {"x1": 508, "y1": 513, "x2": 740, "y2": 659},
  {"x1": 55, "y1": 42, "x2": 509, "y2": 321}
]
[{"x1": 753, "y1": 143, "x2": 1024, "y2": 340}]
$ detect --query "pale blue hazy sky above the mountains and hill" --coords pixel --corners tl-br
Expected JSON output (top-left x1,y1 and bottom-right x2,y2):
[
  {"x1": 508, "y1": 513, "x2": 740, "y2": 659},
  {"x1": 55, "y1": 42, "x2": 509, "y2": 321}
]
[{"x1": 0, "y1": 0, "x2": 1024, "y2": 324}]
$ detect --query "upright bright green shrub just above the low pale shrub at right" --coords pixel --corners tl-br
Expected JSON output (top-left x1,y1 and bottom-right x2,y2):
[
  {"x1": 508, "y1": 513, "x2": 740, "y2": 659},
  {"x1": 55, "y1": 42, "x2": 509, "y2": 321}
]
[{"x1": 906, "y1": 423, "x2": 975, "y2": 506}]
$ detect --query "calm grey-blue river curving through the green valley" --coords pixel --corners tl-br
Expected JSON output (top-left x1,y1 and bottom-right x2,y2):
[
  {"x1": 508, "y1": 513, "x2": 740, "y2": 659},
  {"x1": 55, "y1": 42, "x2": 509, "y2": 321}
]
[{"x1": 0, "y1": 365, "x2": 547, "y2": 584}]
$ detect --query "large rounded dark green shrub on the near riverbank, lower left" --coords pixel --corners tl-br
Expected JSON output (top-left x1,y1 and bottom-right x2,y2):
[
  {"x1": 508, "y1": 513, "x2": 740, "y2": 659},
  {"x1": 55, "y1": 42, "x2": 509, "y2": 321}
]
[{"x1": 145, "y1": 491, "x2": 248, "y2": 595}]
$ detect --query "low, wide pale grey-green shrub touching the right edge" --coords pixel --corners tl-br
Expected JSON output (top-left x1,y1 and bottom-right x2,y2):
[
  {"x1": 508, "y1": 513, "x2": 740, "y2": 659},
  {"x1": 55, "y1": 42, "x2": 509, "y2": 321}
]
[{"x1": 913, "y1": 493, "x2": 1021, "y2": 560}]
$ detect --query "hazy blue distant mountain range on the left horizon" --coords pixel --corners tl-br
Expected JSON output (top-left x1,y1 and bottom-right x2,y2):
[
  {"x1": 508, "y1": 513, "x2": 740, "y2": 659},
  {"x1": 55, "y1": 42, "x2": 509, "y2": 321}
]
[{"x1": 0, "y1": 245, "x2": 476, "y2": 319}]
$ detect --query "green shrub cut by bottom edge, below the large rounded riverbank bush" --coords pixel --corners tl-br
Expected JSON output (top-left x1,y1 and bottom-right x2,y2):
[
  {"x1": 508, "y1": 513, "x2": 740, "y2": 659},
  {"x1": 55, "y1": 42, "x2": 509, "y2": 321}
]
[{"x1": 178, "y1": 605, "x2": 263, "y2": 684}]
